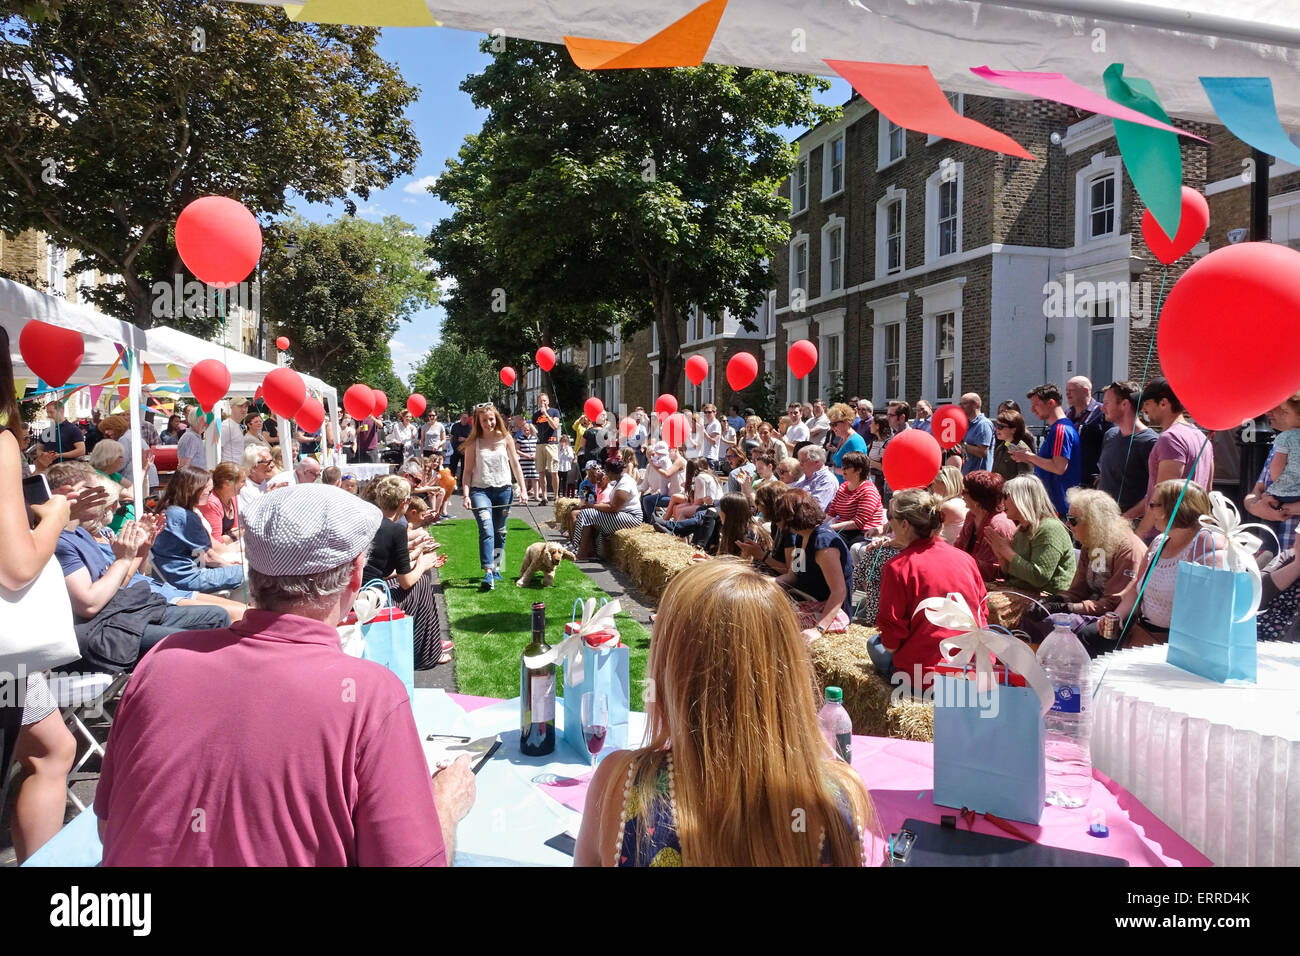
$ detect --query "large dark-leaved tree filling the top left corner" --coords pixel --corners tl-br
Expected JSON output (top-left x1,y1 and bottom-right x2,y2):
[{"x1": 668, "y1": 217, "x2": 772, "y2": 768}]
[{"x1": 0, "y1": 0, "x2": 420, "y2": 334}]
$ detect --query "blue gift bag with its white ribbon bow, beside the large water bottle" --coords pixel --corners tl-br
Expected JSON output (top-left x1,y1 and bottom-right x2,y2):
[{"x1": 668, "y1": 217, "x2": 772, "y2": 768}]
[{"x1": 917, "y1": 594, "x2": 1053, "y2": 823}]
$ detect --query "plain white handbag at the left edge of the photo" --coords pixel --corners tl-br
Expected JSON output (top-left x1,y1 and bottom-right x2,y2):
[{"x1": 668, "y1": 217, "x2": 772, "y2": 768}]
[{"x1": 0, "y1": 557, "x2": 81, "y2": 680}]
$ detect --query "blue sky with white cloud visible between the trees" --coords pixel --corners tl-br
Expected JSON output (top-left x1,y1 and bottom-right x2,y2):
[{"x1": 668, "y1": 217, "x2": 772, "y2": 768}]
[{"x1": 295, "y1": 27, "x2": 852, "y2": 390}]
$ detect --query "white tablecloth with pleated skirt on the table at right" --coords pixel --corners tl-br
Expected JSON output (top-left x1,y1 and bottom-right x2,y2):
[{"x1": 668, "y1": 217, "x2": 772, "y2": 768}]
[{"x1": 1092, "y1": 641, "x2": 1300, "y2": 866}]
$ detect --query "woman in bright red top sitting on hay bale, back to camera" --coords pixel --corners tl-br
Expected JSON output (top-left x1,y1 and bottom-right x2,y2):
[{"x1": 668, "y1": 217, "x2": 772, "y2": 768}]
[{"x1": 867, "y1": 488, "x2": 987, "y2": 691}]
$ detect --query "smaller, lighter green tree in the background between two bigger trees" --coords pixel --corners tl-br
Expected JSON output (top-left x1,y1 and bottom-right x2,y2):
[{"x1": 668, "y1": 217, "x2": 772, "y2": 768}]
[{"x1": 261, "y1": 216, "x2": 438, "y2": 392}]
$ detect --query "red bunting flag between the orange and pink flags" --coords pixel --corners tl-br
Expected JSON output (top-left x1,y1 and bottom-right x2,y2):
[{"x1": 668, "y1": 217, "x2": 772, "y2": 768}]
[{"x1": 826, "y1": 60, "x2": 1034, "y2": 160}]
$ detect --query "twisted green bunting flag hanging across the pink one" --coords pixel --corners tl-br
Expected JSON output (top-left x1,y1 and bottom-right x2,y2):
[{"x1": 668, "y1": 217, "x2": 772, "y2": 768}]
[{"x1": 1102, "y1": 62, "x2": 1183, "y2": 235}]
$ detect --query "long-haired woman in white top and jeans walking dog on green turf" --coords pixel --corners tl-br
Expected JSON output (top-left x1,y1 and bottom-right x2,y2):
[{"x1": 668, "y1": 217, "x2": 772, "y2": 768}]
[{"x1": 460, "y1": 402, "x2": 528, "y2": 591}]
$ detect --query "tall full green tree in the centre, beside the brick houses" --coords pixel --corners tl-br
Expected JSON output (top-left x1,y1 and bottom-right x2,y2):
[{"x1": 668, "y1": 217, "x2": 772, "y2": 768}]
[{"x1": 430, "y1": 40, "x2": 836, "y2": 392}]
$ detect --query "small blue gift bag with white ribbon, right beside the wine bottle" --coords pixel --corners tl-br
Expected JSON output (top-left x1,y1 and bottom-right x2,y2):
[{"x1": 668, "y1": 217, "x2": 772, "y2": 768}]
[{"x1": 559, "y1": 598, "x2": 632, "y2": 756}]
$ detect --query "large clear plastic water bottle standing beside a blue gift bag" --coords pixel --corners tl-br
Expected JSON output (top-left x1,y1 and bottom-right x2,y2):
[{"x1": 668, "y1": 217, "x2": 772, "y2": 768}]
[{"x1": 1037, "y1": 614, "x2": 1092, "y2": 808}]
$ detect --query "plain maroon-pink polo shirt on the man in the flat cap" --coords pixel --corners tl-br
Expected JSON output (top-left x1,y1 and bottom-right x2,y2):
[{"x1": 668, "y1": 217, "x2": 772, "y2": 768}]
[{"x1": 95, "y1": 610, "x2": 447, "y2": 866}]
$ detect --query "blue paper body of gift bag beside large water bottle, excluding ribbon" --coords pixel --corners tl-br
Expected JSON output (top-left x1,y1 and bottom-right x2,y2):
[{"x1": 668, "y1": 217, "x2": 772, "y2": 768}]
[{"x1": 933, "y1": 675, "x2": 1047, "y2": 823}]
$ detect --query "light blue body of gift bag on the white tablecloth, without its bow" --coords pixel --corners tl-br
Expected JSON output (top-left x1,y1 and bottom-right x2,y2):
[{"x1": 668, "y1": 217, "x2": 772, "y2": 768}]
[{"x1": 1165, "y1": 561, "x2": 1257, "y2": 683}]
